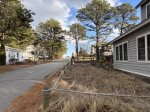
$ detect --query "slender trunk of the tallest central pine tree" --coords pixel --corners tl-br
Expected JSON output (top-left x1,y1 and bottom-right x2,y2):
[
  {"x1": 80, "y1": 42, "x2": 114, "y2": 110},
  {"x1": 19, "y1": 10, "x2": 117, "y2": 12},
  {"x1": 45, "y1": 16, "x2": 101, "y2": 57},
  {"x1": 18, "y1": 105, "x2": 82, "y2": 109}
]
[{"x1": 96, "y1": 26, "x2": 100, "y2": 62}]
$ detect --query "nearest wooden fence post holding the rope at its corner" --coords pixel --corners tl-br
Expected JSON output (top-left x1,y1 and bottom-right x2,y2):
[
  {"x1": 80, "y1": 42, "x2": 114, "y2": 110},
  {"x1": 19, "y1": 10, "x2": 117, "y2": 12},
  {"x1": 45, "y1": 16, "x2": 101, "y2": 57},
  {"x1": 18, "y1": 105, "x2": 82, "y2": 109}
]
[{"x1": 43, "y1": 86, "x2": 51, "y2": 112}]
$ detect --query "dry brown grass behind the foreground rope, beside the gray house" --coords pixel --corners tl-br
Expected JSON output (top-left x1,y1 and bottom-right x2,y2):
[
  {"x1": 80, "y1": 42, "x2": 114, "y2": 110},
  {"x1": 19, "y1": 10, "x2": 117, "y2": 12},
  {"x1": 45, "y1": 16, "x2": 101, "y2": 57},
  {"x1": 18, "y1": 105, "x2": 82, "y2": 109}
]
[{"x1": 62, "y1": 64, "x2": 150, "y2": 95}]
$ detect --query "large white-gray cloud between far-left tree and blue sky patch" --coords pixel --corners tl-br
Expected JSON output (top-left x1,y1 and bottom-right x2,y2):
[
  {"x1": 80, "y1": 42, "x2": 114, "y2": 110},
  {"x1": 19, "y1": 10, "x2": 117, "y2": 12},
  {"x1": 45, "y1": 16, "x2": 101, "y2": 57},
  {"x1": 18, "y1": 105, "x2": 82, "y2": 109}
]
[{"x1": 22, "y1": 0, "x2": 70, "y2": 28}]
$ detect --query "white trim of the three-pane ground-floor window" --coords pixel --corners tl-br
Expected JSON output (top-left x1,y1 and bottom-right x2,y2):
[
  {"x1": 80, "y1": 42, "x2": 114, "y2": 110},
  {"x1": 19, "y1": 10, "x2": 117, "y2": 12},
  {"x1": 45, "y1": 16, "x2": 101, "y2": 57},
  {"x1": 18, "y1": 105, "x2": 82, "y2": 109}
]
[{"x1": 115, "y1": 41, "x2": 129, "y2": 62}]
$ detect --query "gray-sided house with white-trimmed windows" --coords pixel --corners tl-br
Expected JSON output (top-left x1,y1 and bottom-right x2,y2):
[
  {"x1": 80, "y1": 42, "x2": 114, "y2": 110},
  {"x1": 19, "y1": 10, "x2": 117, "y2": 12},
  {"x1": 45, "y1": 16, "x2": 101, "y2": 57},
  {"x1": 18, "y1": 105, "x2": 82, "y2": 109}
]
[{"x1": 111, "y1": 0, "x2": 150, "y2": 77}]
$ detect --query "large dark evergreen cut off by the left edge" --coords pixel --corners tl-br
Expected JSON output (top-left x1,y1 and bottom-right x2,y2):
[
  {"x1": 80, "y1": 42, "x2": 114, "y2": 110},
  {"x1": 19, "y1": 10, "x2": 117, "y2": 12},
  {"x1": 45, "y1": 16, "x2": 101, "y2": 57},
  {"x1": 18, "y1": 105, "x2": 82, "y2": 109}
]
[{"x1": 0, "y1": 0, "x2": 33, "y2": 65}]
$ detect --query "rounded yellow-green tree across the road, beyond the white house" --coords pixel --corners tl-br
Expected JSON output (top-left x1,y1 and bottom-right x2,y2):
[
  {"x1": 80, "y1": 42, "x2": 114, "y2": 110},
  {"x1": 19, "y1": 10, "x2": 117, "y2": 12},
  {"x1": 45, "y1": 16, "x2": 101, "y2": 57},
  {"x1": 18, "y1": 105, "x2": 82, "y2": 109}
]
[{"x1": 36, "y1": 19, "x2": 66, "y2": 59}]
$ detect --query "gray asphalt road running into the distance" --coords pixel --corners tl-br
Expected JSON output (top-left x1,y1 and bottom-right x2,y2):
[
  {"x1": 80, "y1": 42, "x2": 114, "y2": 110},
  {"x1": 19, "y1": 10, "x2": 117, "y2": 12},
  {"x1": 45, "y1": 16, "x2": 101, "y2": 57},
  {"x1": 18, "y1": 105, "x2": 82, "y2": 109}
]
[{"x1": 0, "y1": 61, "x2": 67, "y2": 112}]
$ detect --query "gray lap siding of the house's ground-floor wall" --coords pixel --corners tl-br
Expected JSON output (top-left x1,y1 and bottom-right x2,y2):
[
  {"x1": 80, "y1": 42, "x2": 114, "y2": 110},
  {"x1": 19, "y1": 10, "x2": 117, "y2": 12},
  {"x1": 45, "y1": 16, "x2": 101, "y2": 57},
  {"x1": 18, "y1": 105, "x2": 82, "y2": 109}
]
[{"x1": 114, "y1": 24, "x2": 150, "y2": 76}]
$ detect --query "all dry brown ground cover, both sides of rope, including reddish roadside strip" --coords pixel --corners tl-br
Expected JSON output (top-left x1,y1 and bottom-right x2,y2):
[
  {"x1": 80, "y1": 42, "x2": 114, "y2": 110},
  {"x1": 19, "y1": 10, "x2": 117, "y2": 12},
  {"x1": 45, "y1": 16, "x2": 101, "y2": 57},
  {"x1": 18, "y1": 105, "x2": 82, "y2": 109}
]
[{"x1": 5, "y1": 63, "x2": 150, "y2": 112}]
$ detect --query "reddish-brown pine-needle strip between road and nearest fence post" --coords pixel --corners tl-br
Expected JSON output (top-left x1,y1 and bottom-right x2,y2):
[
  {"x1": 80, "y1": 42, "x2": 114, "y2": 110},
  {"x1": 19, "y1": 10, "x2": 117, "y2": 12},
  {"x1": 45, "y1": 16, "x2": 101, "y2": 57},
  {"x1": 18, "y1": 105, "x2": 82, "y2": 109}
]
[{"x1": 5, "y1": 84, "x2": 43, "y2": 112}]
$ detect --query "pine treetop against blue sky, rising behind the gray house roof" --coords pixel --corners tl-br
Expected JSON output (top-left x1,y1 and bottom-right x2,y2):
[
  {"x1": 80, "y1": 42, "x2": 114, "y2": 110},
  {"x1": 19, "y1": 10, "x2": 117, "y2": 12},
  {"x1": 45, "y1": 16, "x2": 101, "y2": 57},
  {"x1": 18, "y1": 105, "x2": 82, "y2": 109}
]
[{"x1": 114, "y1": 3, "x2": 139, "y2": 35}]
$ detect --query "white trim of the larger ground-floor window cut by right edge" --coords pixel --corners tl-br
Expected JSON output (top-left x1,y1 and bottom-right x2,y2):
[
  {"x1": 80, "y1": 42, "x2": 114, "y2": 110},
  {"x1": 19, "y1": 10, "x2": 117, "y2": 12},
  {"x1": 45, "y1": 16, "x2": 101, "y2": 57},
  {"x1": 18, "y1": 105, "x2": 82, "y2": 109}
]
[{"x1": 136, "y1": 32, "x2": 150, "y2": 63}]
